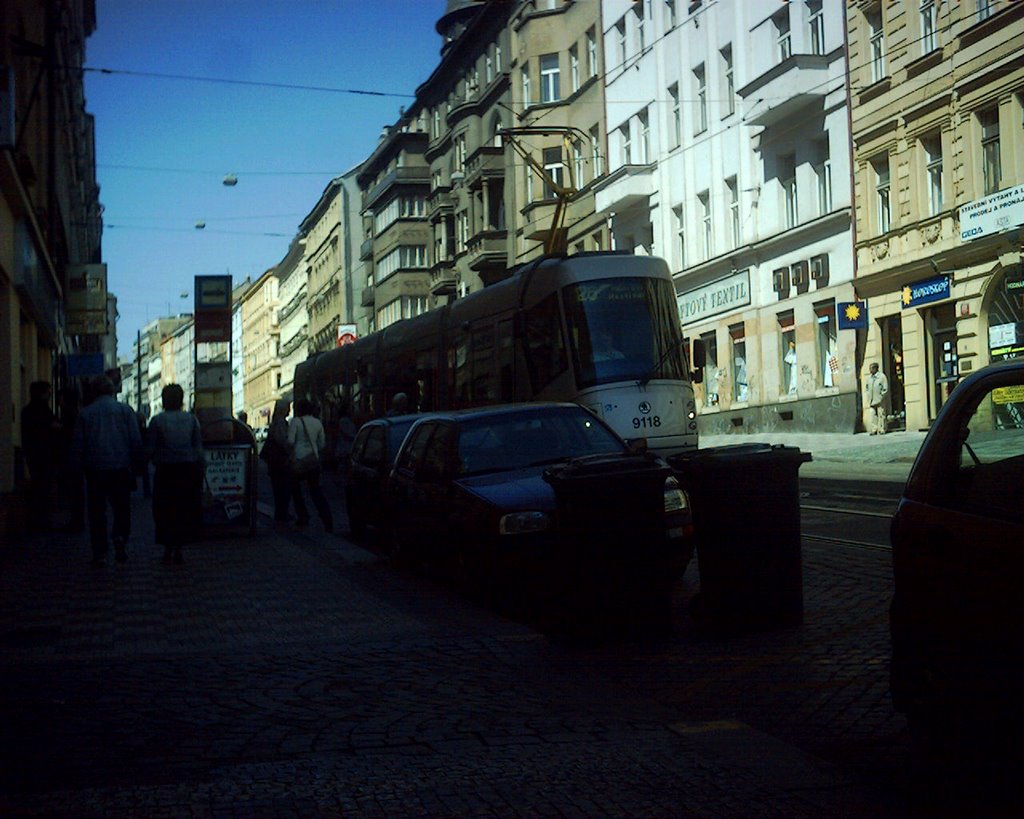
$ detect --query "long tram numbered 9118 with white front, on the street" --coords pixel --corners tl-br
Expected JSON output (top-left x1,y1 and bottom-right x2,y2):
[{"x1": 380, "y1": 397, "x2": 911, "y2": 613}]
[{"x1": 294, "y1": 252, "x2": 700, "y2": 455}]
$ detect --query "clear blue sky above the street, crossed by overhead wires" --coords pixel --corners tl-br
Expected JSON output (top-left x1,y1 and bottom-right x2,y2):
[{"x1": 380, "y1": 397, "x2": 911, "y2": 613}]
[{"x1": 85, "y1": 0, "x2": 445, "y2": 355}]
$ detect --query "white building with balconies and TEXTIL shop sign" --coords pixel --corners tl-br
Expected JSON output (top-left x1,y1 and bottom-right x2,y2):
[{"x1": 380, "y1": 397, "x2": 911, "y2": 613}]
[{"x1": 597, "y1": 0, "x2": 859, "y2": 434}]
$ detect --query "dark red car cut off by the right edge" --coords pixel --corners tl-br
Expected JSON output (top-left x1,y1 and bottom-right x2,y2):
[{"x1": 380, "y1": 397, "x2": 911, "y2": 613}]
[{"x1": 891, "y1": 359, "x2": 1024, "y2": 760}]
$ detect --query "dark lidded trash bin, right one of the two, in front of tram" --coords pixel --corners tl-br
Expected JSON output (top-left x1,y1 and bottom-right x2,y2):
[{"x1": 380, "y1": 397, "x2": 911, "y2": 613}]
[{"x1": 669, "y1": 443, "x2": 811, "y2": 633}]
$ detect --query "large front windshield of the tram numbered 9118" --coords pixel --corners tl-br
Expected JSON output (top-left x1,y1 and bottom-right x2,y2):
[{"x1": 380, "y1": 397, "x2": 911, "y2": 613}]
[{"x1": 562, "y1": 277, "x2": 686, "y2": 388}]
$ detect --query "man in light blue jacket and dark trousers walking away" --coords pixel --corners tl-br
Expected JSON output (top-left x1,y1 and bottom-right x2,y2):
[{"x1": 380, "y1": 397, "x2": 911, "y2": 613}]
[{"x1": 72, "y1": 376, "x2": 143, "y2": 565}]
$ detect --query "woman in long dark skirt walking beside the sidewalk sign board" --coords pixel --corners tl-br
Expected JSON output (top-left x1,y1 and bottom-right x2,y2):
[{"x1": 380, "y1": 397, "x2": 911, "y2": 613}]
[{"x1": 150, "y1": 384, "x2": 203, "y2": 563}]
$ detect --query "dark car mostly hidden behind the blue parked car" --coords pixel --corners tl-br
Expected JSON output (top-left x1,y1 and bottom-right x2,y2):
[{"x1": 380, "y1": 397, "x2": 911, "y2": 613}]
[{"x1": 345, "y1": 415, "x2": 422, "y2": 537}]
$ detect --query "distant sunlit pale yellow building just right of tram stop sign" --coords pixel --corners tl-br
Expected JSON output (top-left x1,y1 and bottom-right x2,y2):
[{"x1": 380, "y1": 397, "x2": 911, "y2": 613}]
[{"x1": 241, "y1": 267, "x2": 281, "y2": 428}]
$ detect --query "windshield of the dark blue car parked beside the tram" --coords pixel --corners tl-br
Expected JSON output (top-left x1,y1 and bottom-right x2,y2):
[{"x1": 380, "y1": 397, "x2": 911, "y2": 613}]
[{"x1": 459, "y1": 407, "x2": 627, "y2": 475}]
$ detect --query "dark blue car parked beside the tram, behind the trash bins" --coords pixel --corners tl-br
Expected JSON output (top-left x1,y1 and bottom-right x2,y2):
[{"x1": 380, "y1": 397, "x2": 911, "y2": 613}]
[{"x1": 386, "y1": 403, "x2": 693, "y2": 614}]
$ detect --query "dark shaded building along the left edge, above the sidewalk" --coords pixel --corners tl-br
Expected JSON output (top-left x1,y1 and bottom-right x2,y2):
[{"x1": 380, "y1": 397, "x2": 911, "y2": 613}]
[{"x1": 0, "y1": 0, "x2": 102, "y2": 541}]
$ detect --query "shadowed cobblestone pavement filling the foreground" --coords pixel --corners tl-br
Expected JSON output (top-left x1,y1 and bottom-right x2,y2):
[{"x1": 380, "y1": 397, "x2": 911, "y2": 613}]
[{"x1": 0, "y1": 444, "x2": 987, "y2": 816}]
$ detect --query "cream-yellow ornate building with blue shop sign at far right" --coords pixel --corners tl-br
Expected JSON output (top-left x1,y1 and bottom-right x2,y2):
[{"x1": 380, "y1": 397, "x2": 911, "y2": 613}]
[{"x1": 846, "y1": 0, "x2": 1024, "y2": 429}]
